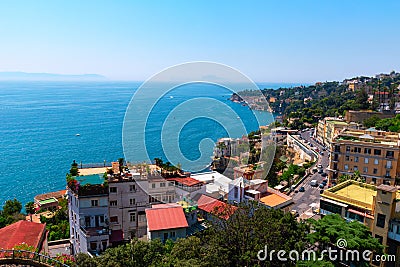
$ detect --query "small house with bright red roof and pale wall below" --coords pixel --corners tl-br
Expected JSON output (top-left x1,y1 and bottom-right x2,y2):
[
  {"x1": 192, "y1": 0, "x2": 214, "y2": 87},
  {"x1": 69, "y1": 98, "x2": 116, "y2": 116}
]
[{"x1": 146, "y1": 204, "x2": 189, "y2": 242}]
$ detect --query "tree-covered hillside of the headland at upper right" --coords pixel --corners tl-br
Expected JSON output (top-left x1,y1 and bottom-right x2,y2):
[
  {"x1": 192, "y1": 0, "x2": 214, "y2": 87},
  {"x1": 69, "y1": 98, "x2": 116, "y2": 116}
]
[{"x1": 255, "y1": 72, "x2": 400, "y2": 131}]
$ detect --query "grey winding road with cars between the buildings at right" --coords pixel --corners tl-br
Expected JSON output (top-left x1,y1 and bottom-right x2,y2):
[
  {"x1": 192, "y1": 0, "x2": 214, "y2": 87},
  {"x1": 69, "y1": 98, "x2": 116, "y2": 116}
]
[{"x1": 291, "y1": 130, "x2": 329, "y2": 219}]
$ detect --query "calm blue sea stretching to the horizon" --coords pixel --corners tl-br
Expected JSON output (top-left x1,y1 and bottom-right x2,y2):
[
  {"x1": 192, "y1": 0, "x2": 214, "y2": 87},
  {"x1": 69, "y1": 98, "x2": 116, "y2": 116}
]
[{"x1": 0, "y1": 81, "x2": 300, "y2": 207}]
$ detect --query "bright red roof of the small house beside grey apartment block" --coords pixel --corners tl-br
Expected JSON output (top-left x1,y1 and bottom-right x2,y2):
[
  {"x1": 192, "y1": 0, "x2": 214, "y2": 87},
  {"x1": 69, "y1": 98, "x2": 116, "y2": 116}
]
[{"x1": 146, "y1": 204, "x2": 189, "y2": 231}]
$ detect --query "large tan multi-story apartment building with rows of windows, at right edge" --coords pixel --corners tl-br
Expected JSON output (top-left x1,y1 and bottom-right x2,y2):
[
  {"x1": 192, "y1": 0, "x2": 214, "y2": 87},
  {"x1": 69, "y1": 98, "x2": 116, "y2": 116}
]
[{"x1": 327, "y1": 129, "x2": 400, "y2": 185}]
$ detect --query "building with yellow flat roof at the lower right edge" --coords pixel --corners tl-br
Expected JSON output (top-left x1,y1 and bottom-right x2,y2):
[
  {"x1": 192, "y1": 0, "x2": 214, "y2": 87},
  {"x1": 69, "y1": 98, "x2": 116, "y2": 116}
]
[{"x1": 320, "y1": 180, "x2": 400, "y2": 266}]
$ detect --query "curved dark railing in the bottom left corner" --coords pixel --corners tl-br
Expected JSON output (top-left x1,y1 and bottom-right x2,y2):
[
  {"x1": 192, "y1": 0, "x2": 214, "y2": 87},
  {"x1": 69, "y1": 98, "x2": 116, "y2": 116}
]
[{"x1": 0, "y1": 249, "x2": 70, "y2": 267}]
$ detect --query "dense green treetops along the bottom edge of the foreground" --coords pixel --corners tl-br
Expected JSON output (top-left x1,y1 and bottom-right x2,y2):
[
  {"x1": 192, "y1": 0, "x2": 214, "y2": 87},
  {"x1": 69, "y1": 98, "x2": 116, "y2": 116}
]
[{"x1": 69, "y1": 206, "x2": 383, "y2": 267}]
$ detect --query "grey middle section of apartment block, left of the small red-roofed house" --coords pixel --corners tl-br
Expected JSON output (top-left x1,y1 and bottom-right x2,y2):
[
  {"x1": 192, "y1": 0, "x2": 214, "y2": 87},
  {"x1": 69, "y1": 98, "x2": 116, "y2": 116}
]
[{"x1": 108, "y1": 172, "x2": 150, "y2": 244}]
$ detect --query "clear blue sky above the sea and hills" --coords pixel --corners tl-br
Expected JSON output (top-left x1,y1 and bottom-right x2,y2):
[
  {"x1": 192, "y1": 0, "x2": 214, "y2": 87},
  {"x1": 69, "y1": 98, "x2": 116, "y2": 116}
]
[{"x1": 0, "y1": 0, "x2": 400, "y2": 82}]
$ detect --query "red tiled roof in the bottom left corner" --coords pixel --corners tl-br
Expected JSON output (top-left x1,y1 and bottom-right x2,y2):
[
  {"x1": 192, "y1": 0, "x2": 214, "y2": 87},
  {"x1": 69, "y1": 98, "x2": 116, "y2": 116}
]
[{"x1": 0, "y1": 221, "x2": 46, "y2": 249}]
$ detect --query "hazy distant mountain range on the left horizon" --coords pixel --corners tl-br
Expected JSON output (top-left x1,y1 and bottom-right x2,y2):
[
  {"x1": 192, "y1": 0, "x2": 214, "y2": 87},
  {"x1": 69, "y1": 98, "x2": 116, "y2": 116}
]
[{"x1": 0, "y1": 71, "x2": 107, "y2": 81}]
